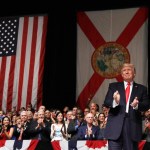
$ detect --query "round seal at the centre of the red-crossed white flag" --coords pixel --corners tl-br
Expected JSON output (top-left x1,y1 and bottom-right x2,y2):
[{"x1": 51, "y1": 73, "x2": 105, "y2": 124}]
[{"x1": 91, "y1": 42, "x2": 130, "y2": 79}]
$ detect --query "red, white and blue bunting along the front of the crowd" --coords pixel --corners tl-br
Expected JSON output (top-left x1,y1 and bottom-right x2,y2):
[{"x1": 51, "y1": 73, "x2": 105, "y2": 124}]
[{"x1": 0, "y1": 140, "x2": 146, "y2": 150}]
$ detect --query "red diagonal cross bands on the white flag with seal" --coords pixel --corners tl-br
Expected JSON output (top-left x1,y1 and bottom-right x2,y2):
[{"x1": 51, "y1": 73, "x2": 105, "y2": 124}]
[{"x1": 77, "y1": 8, "x2": 148, "y2": 109}]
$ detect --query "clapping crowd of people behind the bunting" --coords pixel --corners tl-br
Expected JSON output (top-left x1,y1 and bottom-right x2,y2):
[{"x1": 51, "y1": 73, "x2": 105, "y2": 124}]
[{"x1": 0, "y1": 102, "x2": 150, "y2": 141}]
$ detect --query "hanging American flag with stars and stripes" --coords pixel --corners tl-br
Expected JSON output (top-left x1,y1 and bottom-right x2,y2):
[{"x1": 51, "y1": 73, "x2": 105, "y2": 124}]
[{"x1": 0, "y1": 15, "x2": 48, "y2": 111}]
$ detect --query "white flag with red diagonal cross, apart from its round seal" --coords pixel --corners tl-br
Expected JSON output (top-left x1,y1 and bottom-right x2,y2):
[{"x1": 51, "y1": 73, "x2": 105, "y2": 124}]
[{"x1": 76, "y1": 7, "x2": 148, "y2": 109}]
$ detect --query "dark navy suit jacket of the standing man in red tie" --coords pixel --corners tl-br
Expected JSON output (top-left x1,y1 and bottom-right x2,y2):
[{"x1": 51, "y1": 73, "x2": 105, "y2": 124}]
[{"x1": 104, "y1": 82, "x2": 150, "y2": 142}]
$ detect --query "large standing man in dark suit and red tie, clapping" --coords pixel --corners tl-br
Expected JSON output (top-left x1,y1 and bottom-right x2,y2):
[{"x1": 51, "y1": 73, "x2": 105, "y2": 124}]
[{"x1": 104, "y1": 63, "x2": 150, "y2": 150}]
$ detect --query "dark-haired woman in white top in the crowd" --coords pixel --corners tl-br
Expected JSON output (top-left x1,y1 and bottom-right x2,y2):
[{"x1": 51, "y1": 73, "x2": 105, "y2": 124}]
[{"x1": 50, "y1": 112, "x2": 68, "y2": 141}]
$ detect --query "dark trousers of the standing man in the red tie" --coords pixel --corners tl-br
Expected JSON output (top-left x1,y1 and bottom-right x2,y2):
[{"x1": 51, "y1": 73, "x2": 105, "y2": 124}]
[{"x1": 108, "y1": 117, "x2": 138, "y2": 150}]
